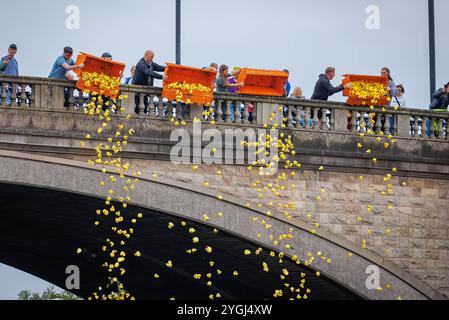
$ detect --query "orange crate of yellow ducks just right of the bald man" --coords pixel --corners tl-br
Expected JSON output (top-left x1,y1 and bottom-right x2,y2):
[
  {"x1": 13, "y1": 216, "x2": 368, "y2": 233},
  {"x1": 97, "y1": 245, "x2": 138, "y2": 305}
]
[{"x1": 162, "y1": 63, "x2": 217, "y2": 105}]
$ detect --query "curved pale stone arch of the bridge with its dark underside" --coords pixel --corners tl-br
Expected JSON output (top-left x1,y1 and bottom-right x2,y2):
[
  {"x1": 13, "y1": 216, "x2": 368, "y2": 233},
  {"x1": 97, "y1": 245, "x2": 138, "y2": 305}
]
[{"x1": 0, "y1": 151, "x2": 442, "y2": 300}]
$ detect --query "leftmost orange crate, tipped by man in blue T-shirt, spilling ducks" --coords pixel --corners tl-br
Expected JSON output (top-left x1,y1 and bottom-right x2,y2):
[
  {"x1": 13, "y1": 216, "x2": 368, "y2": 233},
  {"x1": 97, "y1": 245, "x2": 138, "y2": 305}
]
[{"x1": 74, "y1": 52, "x2": 126, "y2": 98}]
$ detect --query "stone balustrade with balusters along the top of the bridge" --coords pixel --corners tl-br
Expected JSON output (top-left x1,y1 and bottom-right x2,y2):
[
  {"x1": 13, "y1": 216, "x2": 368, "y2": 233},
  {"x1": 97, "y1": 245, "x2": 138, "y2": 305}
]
[{"x1": 0, "y1": 76, "x2": 449, "y2": 140}]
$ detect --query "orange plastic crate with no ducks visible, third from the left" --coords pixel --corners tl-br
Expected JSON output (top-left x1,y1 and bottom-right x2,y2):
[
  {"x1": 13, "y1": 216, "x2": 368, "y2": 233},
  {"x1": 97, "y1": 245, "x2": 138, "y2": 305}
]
[{"x1": 237, "y1": 68, "x2": 288, "y2": 97}]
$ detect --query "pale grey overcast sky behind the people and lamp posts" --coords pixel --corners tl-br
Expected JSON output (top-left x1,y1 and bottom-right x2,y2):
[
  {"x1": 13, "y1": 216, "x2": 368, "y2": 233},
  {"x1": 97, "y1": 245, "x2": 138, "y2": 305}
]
[{"x1": 0, "y1": 0, "x2": 449, "y2": 299}]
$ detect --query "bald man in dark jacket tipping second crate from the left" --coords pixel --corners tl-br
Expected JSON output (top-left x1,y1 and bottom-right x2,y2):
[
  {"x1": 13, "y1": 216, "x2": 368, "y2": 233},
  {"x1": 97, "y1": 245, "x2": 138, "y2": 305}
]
[{"x1": 132, "y1": 50, "x2": 166, "y2": 115}]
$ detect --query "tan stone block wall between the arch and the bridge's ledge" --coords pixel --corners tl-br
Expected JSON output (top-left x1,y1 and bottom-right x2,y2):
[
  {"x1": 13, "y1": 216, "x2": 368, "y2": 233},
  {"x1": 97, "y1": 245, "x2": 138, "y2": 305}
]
[{"x1": 70, "y1": 158, "x2": 449, "y2": 298}]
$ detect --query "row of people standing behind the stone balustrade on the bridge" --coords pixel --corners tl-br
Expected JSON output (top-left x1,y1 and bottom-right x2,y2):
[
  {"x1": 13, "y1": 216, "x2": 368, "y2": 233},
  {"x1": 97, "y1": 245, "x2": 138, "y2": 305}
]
[{"x1": 0, "y1": 44, "x2": 449, "y2": 134}]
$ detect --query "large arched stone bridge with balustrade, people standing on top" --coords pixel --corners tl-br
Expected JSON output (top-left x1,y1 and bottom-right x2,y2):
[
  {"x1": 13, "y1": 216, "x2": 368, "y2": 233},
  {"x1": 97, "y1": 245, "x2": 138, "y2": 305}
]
[{"x1": 0, "y1": 77, "x2": 449, "y2": 299}]
